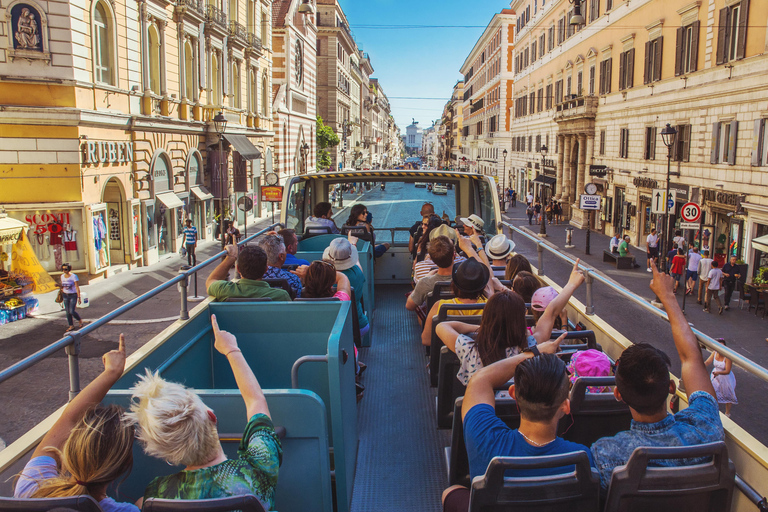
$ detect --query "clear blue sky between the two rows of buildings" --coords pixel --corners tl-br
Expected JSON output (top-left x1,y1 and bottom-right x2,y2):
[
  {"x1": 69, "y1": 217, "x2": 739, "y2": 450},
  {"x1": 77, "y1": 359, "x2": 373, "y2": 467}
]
[{"x1": 339, "y1": 0, "x2": 509, "y2": 134}]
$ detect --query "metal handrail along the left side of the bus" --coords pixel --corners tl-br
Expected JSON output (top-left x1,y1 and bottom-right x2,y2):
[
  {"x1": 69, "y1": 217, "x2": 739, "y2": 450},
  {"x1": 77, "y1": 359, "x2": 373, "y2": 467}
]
[{"x1": 0, "y1": 222, "x2": 282, "y2": 400}]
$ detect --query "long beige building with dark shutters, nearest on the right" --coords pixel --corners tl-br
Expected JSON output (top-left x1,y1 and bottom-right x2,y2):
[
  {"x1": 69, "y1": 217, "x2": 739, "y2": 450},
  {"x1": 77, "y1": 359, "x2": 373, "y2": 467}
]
[{"x1": 510, "y1": 0, "x2": 768, "y2": 272}]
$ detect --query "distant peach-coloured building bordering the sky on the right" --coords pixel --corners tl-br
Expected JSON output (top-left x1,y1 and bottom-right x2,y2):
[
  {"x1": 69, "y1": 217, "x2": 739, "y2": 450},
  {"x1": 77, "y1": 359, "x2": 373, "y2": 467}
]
[{"x1": 460, "y1": 9, "x2": 516, "y2": 182}]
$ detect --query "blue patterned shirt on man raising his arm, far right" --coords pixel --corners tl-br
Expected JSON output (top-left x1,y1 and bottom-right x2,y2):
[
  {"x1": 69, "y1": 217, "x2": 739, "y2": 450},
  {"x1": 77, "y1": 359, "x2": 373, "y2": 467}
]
[{"x1": 592, "y1": 391, "x2": 725, "y2": 490}]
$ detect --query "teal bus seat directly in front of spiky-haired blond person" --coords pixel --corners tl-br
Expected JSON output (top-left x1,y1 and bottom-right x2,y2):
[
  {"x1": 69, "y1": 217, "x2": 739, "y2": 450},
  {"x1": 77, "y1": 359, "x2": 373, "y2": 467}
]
[{"x1": 104, "y1": 386, "x2": 332, "y2": 512}]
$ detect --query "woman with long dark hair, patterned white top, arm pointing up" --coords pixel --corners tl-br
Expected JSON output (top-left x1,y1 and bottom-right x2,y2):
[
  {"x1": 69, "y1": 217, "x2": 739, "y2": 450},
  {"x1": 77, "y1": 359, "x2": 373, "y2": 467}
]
[{"x1": 435, "y1": 260, "x2": 584, "y2": 386}]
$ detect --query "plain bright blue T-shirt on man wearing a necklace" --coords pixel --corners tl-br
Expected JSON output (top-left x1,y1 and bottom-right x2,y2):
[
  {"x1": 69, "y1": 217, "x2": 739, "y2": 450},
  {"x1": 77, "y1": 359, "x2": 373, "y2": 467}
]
[{"x1": 464, "y1": 404, "x2": 595, "y2": 478}]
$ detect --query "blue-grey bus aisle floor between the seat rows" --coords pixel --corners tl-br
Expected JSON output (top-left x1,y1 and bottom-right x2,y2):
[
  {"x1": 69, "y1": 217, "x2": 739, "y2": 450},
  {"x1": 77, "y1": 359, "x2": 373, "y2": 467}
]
[{"x1": 351, "y1": 285, "x2": 451, "y2": 512}]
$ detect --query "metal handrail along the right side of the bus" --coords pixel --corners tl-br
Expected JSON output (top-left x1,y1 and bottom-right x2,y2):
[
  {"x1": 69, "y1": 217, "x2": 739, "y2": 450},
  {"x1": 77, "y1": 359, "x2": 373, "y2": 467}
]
[{"x1": 501, "y1": 221, "x2": 768, "y2": 382}]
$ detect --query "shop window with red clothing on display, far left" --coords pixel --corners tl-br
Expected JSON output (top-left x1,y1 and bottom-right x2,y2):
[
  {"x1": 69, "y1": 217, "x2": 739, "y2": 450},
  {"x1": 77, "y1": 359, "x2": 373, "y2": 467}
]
[{"x1": 7, "y1": 209, "x2": 87, "y2": 272}]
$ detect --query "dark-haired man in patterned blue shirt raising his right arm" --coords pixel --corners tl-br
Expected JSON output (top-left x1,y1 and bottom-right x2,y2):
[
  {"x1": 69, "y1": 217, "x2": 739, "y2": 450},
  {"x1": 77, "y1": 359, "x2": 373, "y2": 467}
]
[{"x1": 592, "y1": 265, "x2": 724, "y2": 490}]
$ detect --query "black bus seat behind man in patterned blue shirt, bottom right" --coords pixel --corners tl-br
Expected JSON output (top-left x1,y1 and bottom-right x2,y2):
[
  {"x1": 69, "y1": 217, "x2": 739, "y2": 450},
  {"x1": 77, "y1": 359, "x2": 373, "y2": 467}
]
[{"x1": 605, "y1": 442, "x2": 736, "y2": 512}]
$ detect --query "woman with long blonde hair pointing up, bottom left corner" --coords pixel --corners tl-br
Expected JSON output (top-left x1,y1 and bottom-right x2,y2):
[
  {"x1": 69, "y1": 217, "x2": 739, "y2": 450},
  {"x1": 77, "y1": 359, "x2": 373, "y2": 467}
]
[{"x1": 13, "y1": 334, "x2": 139, "y2": 512}]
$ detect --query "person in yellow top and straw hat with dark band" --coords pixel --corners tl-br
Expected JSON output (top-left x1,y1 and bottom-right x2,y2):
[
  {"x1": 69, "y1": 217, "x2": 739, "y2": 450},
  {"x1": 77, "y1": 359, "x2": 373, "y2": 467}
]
[{"x1": 421, "y1": 250, "x2": 491, "y2": 347}]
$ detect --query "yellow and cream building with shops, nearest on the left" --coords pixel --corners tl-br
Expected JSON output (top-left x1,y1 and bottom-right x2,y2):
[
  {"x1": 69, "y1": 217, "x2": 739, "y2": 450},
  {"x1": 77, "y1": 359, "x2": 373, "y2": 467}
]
[{"x1": 0, "y1": 0, "x2": 272, "y2": 278}]
